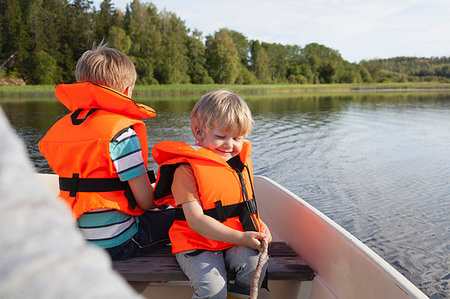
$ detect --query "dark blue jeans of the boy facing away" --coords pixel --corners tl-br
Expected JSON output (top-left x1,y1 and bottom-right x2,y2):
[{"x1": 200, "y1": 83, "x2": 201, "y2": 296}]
[{"x1": 106, "y1": 209, "x2": 175, "y2": 260}]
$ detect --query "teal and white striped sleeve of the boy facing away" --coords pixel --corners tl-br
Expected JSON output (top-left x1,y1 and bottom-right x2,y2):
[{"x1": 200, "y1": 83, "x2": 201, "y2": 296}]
[{"x1": 109, "y1": 127, "x2": 147, "y2": 181}]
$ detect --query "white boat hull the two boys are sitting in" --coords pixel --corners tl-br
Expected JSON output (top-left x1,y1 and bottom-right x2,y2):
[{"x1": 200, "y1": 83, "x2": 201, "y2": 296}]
[{"x1": 35, "y1": 174, "x2": 427, "y2": 299}]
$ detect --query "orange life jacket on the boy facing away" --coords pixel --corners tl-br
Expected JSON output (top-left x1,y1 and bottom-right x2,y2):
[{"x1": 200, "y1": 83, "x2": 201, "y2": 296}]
[{"x1": 39, "y1": 82, "x2": 156, "y2": 219}]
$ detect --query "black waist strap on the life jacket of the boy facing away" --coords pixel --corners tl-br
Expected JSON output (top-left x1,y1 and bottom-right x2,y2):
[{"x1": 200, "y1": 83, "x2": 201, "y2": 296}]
[{"x1": 59, "y1": 170, "x2": 156, "y2": 209}]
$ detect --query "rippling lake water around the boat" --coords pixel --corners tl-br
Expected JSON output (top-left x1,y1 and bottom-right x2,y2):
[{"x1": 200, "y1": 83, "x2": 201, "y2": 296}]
[{"x1": 0, "y1": 92, "x2": 450, "y2": 298}]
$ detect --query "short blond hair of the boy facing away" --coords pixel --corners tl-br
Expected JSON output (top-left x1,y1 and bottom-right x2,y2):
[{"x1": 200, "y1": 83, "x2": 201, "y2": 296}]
[{"x1": 75, "y1": 41, "x2": 136, "y2": 92}]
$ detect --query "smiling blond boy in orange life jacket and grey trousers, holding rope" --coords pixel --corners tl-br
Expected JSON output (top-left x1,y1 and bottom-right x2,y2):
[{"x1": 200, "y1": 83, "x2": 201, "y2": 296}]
[{"x1": 153, "y1": 90, "x2": 272, "y2": 298}]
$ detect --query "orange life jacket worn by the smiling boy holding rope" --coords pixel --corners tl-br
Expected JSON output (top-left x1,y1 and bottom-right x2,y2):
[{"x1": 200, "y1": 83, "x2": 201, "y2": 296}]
[{"x1": 153, "y1": 141, "x2": 261, "y2": 253}]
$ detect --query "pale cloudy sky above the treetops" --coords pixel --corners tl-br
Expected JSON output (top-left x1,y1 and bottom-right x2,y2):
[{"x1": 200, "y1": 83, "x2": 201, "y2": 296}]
[{"x1": 94, "y1": 0, "x2": 450, "y2": 62}]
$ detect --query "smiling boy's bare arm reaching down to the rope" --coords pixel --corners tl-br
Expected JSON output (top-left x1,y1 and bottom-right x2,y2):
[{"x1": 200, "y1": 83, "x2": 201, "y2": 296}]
[{"x1": 182, "y1": 201, "x2": 267, "y2": 250}]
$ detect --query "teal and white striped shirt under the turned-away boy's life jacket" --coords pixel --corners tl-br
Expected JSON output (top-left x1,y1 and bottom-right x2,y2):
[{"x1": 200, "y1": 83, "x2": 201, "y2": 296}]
[{"x1": 78, "y1": 127, "x2": 147, "y2": 248}]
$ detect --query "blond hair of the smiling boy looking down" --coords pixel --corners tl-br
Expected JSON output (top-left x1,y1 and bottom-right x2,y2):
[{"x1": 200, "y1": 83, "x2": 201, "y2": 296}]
[{"x1": 191, "y1": 89, "x2": 253, "y2": 136}]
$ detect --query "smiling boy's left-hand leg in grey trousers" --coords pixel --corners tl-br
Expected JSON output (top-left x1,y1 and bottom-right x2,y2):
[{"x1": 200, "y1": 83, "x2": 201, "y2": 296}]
[{"x1": 175, "y1": 250, "x2": 227, "y2": 299}]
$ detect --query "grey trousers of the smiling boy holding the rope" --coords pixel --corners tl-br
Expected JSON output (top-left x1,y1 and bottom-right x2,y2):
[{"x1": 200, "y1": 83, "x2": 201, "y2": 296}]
[{"x1": 175, "y1": 246, "x2": 268, "y2": 299}]
